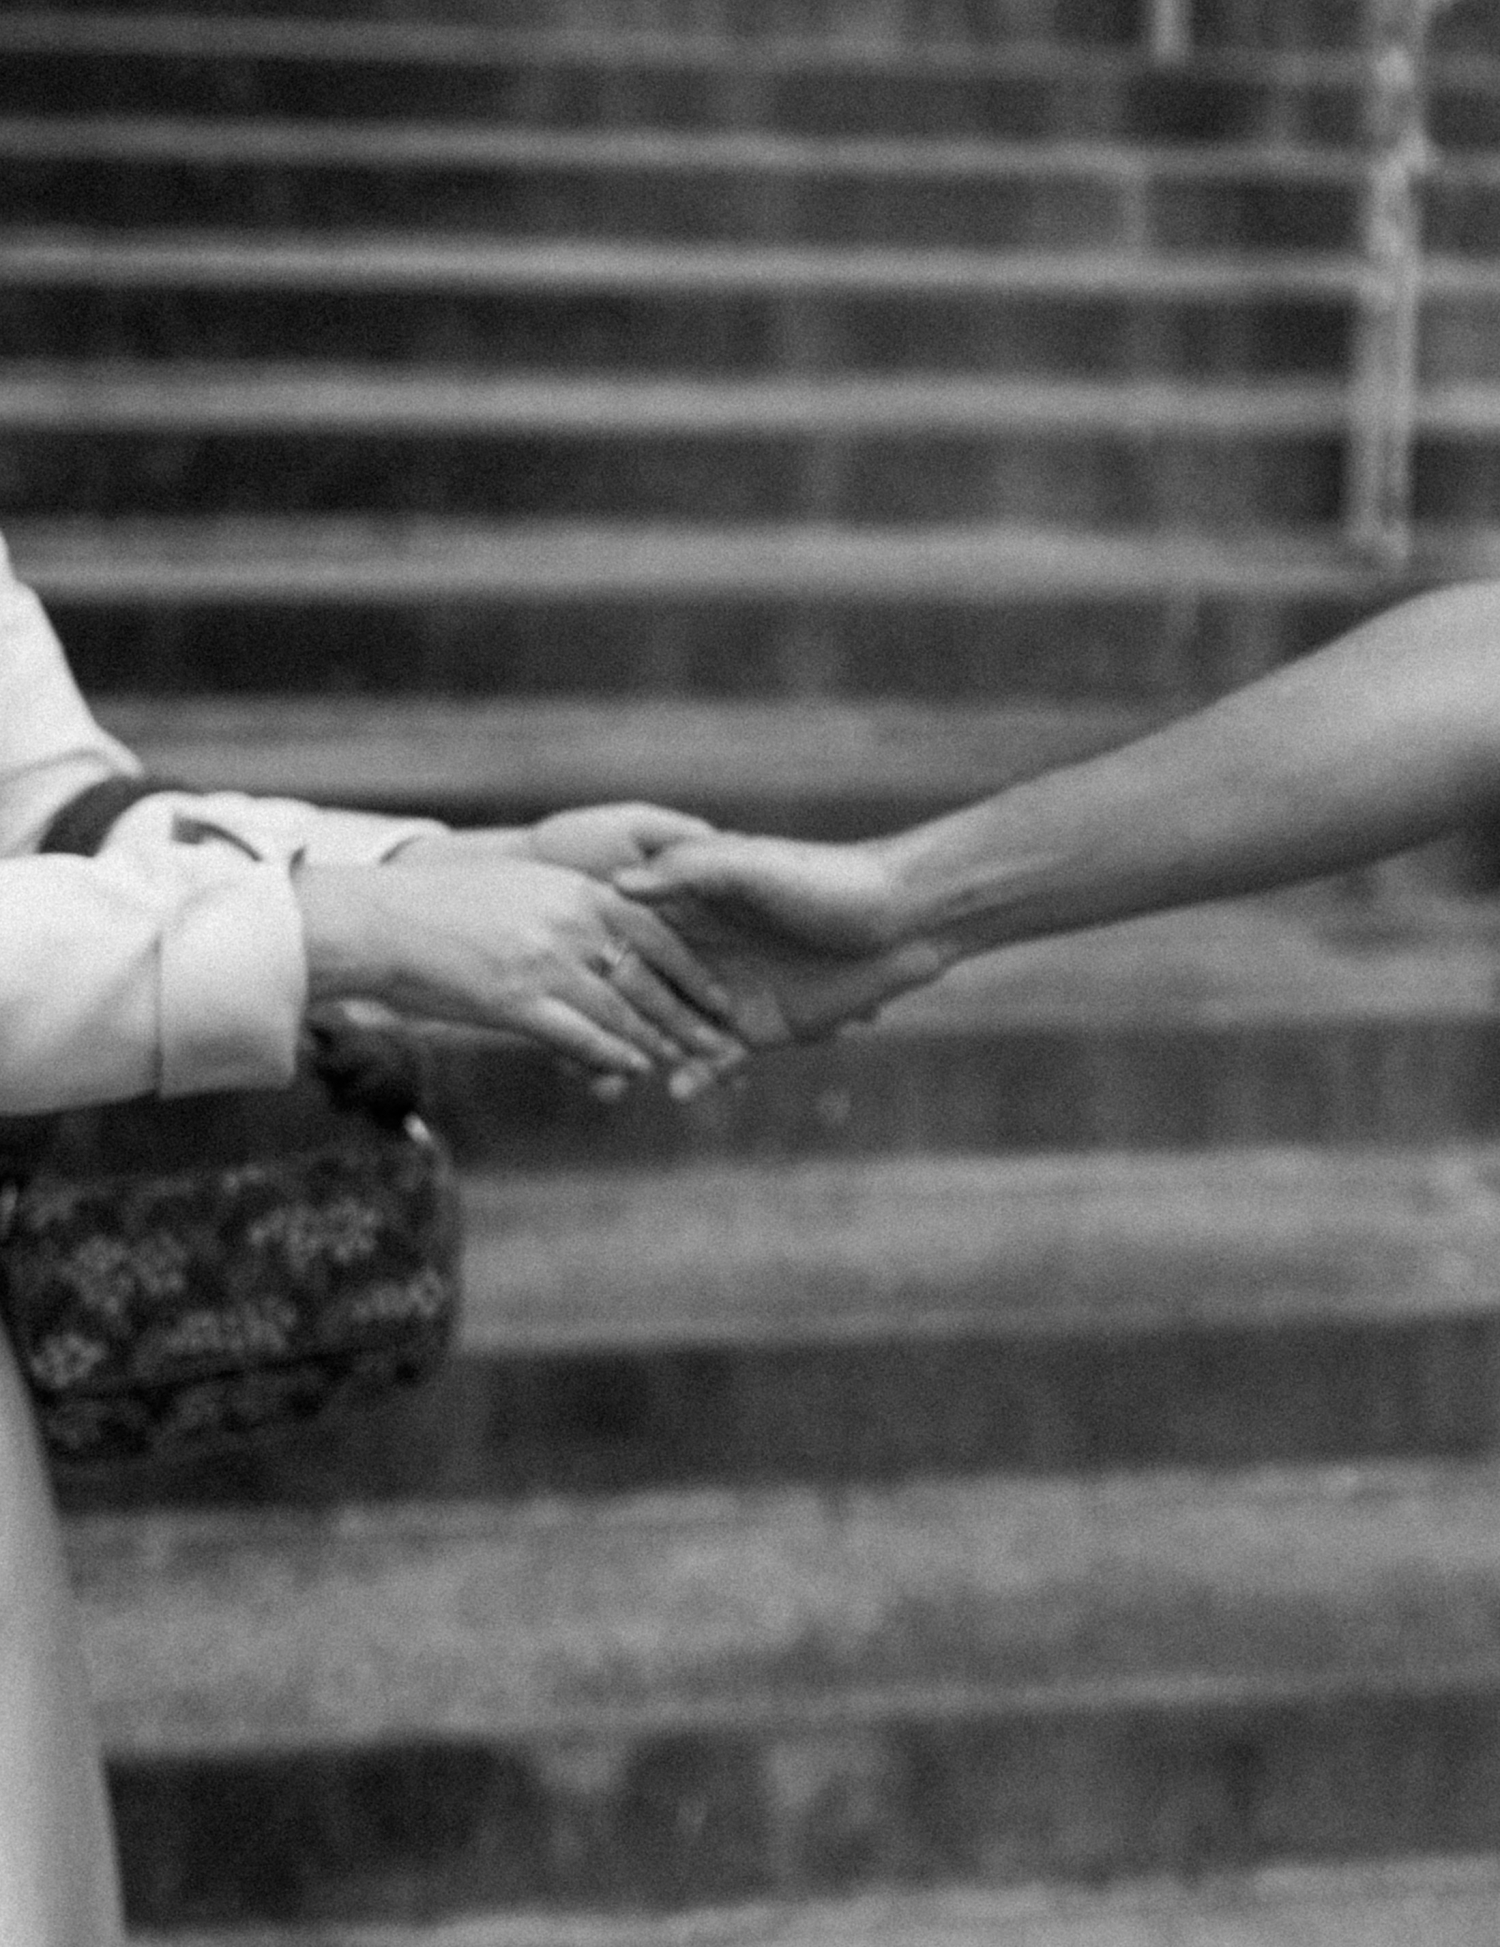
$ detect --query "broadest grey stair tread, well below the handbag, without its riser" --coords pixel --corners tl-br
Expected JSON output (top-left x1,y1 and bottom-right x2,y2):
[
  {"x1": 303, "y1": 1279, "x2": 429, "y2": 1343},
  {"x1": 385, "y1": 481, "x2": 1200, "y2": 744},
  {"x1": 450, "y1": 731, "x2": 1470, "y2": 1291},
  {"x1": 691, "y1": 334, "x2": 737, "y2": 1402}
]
[{"x1": 68, "y1": 1462, "x2": 1500, "y2": 1756}]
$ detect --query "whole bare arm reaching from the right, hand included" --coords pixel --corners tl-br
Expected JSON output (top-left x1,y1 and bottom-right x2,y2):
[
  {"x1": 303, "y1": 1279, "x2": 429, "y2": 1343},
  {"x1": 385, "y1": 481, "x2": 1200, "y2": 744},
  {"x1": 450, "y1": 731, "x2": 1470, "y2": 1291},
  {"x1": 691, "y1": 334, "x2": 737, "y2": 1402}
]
[{"x1": 616, "y1": 582, "x2": 1500, "y2": 1042}]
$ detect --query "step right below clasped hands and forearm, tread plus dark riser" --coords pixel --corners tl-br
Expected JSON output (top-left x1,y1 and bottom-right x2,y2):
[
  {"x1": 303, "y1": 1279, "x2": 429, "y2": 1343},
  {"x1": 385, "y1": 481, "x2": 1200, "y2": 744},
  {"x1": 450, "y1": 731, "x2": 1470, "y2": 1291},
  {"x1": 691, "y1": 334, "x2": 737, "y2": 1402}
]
[{"x1": 401, "y1": 901, "x2": 1500, "y2": 1170}]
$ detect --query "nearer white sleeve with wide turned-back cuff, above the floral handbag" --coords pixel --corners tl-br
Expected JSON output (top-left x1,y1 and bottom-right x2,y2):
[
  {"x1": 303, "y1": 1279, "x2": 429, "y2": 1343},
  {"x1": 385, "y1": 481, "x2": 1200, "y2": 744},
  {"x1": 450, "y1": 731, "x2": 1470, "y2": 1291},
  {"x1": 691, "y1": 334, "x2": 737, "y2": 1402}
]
[{"x1": 0, "y1": 845, "x2": 308, "y2": 1114}]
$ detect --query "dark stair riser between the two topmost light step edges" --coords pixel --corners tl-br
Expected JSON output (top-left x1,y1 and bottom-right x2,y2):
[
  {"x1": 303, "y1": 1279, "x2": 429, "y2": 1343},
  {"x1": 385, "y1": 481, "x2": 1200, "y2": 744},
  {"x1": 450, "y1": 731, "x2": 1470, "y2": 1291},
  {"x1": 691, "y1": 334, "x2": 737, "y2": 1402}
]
[{"x1": 0, "y1": 43, "x2": 1371, "y2": 146}]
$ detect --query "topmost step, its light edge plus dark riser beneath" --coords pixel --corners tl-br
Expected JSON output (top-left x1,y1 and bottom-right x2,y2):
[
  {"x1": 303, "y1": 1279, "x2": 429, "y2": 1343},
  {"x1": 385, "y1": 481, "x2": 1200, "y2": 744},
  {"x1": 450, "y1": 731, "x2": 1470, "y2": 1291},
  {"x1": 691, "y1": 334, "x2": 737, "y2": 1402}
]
[{"x1": 0, "y1": 25, "x2": 1379, "y2": 146}]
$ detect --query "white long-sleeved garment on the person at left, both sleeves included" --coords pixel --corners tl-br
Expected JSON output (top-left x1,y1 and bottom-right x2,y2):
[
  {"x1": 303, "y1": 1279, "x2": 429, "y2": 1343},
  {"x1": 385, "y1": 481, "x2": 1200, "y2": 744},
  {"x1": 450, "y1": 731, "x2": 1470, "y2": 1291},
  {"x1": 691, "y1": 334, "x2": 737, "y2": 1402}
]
[{"x1": 0, "y1": 541, "x2": 442, "y2": 1114}]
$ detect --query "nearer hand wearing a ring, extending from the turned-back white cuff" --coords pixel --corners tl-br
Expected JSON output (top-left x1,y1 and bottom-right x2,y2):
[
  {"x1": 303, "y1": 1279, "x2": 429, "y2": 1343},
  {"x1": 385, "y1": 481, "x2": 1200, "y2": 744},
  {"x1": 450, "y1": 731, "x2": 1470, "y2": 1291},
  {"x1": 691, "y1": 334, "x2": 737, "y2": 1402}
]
[{"x1": 296, "y1": 860, "x2": 742, "y2": 1077}]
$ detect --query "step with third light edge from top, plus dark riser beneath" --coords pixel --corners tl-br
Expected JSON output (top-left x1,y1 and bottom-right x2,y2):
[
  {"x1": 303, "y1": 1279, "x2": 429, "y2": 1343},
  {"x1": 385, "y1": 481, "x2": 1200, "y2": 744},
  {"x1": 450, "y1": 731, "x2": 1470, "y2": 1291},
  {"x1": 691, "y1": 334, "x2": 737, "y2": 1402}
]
[{"x1": 0, "y1": 230, "x2": 1371, "y2": 380}]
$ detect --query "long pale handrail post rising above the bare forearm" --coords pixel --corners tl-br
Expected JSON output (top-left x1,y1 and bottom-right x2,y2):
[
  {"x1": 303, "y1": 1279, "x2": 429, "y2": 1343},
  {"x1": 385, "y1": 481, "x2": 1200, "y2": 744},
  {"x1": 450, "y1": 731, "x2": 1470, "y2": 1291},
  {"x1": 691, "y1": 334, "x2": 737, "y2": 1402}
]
[{"x1": 1344, "y1": 0, "x2": 1445, "y2": 572}]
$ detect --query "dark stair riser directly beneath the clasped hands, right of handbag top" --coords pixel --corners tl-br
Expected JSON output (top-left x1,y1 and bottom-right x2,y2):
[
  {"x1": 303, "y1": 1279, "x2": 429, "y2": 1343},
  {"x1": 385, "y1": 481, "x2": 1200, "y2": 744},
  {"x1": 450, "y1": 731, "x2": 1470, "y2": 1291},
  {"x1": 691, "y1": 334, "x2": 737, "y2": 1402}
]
[{"x1": 432, "y1": 1018, "x2": 1500, "y2": 1168}]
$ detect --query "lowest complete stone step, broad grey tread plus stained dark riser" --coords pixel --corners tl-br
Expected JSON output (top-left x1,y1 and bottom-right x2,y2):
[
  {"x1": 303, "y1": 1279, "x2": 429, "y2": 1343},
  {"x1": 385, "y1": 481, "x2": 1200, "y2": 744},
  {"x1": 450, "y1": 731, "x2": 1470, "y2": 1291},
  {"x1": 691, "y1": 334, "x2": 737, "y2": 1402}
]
[{"x1": 70, "y1": 1462, "x2": 1500, "y2": 1924}]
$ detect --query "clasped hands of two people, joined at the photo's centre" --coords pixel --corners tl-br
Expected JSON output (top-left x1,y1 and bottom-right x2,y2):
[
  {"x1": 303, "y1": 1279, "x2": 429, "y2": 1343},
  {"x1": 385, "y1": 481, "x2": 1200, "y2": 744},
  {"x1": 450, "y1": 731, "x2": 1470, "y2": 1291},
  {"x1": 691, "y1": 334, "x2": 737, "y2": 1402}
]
[{"x1": 346, "y1": 804, "x2": 941, "y2": 1096}]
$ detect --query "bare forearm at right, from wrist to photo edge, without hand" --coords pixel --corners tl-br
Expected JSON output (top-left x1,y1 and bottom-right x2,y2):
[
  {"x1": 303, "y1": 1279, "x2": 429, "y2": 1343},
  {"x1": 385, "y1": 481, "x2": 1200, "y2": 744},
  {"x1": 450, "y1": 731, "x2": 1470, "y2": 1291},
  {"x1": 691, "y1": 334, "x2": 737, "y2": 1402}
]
[{"x1": 882, "y1": 582, "x2": 1500, "y2": 954}]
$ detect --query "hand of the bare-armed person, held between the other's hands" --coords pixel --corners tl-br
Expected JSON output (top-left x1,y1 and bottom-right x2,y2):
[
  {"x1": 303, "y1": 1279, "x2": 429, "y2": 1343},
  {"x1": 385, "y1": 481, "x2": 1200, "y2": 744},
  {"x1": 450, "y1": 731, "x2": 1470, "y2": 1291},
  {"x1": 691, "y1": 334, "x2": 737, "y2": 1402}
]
[{"x1": 616, "y1": 833, "x2": 951, "y2": 1047}]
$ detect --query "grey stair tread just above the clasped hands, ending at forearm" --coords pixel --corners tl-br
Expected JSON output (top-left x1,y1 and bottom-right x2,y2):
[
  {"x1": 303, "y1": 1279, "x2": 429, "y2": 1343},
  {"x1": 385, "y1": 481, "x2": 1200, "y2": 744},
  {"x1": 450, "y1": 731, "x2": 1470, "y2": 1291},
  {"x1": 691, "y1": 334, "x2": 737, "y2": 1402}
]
[{"x1": 97, "y1": 697, "x2": 1161, "y2": 804}]
